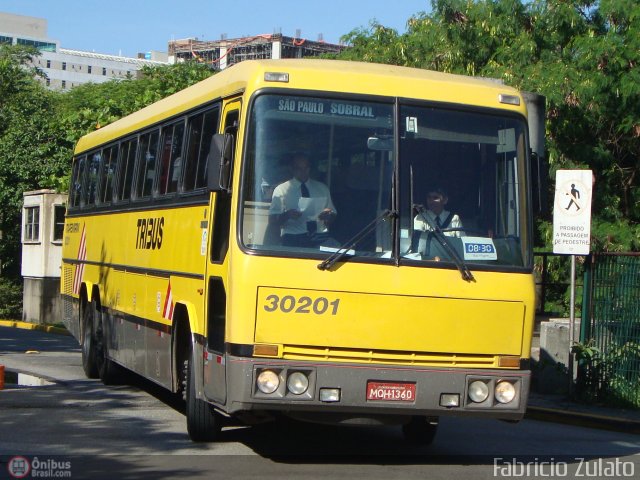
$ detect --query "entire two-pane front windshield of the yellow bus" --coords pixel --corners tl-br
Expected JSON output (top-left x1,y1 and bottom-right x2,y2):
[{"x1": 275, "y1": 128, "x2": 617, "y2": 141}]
[{"x1": 240, "y1": 94, "x2": 531, "y2": 269}]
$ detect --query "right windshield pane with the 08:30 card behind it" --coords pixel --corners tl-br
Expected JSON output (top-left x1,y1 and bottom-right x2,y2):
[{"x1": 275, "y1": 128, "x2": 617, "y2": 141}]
[{"x1": 399, "y1": 106, "x2": 530, "y2": 266}]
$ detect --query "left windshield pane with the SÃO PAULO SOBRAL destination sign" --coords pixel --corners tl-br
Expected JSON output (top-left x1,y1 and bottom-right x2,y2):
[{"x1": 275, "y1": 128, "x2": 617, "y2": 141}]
[{"x1": 242, "y1": 95, "x2": 394, "y2": 258}]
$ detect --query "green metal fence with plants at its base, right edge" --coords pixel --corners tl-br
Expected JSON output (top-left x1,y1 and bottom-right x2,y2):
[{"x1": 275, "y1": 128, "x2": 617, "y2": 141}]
[{"x1": 576, "y1": 253, "x2": 640, "y2": 408}]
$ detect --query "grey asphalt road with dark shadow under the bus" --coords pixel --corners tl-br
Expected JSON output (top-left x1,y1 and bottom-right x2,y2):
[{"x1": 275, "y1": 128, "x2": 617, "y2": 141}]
[{"x1": 0, "y1": 327, "x2": 640, "y2": 479}]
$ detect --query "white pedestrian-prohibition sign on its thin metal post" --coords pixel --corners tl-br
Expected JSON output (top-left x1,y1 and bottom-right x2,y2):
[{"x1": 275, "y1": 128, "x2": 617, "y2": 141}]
[{"x1": 553, "y1": 170, "x2": 593, "y2": 393}]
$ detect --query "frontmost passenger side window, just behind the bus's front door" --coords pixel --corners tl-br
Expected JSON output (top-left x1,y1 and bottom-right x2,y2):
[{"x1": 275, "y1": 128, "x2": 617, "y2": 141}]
[{"x1": 182, "y1": 108, "x2": 219, "y2": 192}]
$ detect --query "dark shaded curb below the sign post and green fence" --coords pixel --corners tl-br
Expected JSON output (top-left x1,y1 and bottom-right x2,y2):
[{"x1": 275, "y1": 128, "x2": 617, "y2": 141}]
[{"x1": 525, "y1": 406, "x2": 640, "y2": 434}]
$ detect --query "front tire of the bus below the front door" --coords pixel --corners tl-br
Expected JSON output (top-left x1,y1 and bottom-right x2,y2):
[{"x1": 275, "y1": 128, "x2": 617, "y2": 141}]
[{"x1": 184, "y1": 348, "x2": 222, "y2": 442}]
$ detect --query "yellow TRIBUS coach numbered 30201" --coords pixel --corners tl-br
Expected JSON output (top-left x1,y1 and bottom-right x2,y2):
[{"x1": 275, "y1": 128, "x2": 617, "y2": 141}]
[{"x1": 61, "y1": 60, "x2": 534, "y2": 443}]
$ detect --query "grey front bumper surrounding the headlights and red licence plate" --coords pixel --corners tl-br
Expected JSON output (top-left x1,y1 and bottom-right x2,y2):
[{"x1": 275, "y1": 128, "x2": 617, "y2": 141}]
[{"x1": 223, "y1": 356, "x2": 531, "y2": 420}]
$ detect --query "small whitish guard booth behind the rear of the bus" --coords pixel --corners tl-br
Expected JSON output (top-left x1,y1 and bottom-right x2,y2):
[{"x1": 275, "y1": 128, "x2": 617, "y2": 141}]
[{"x1": 21, "y1": 190, "x2": 67, "y2": 324}]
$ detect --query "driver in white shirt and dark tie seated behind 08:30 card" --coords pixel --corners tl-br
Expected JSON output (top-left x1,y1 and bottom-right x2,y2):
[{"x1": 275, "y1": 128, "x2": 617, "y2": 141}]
[{"x1": 411, "y1": 187, "x2": 464, "y2": 253}]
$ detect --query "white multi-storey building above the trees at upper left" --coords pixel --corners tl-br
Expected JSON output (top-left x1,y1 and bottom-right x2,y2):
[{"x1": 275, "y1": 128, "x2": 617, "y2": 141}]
[{"x1": 0, "y1": 13, "x2": 168, "y2": 90}]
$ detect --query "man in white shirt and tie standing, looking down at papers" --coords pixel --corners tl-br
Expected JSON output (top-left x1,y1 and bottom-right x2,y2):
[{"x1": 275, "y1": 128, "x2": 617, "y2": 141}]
[{"x1": 269, "y1": 154, "x2": 336, "y2": 248}]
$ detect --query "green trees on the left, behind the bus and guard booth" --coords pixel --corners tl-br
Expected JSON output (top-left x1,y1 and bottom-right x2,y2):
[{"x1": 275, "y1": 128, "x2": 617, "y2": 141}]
[{"x1": 0, "y1": 50, "x2": 212, "y2": 279}]
